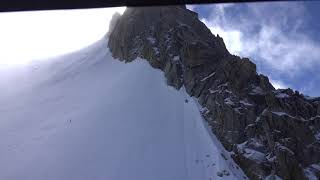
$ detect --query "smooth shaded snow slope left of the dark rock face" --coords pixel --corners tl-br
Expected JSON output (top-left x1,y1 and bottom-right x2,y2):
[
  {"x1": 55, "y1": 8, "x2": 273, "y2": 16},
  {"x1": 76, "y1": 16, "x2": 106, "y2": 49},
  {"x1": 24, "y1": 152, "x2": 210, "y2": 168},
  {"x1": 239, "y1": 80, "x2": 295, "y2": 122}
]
[{"x1": 0, "y1": 40, "x2": 243, "y2": 180}]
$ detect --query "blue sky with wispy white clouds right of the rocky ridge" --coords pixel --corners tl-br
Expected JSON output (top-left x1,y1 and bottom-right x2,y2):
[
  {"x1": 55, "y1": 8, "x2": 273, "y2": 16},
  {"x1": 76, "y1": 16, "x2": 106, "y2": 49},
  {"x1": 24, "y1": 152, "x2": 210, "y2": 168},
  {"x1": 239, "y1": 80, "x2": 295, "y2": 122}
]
[{"x1": 188, "y1": 1, "x2": 320, "y2": 96}]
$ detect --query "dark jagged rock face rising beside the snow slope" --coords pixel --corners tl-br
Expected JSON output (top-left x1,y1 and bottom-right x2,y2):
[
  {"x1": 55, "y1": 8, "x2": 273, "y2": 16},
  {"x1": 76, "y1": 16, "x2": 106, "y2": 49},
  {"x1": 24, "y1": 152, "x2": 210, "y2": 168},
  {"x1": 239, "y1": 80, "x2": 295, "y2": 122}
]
[{"x1": 108, "y1": 6, "x2": 320, "y2": 180}]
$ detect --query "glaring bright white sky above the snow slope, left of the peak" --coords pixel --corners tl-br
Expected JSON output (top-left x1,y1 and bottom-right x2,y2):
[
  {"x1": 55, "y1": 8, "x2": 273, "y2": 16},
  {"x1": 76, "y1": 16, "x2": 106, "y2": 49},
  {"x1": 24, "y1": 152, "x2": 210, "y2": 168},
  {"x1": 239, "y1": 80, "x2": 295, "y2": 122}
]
[{"x1": 0, "y1": 7, "x2": 125, "y2": 66}]
